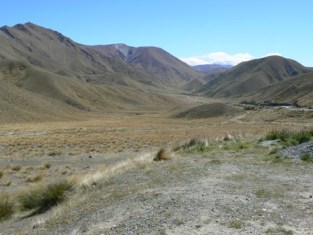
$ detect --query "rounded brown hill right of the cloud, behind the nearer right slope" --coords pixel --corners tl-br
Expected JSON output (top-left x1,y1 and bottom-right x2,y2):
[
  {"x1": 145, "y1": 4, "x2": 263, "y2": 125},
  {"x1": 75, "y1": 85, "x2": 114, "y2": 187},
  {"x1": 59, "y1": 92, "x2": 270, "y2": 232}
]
[{"x1": 200, "y1": 56, "x2": 311, "y2": 97}]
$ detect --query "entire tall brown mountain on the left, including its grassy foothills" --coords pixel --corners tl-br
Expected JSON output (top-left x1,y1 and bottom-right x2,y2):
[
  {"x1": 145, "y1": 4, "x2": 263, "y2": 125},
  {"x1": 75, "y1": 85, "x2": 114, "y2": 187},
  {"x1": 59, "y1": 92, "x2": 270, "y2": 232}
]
[{"x1": 0, "y1": 23, "x2": 197, "y2": 122}]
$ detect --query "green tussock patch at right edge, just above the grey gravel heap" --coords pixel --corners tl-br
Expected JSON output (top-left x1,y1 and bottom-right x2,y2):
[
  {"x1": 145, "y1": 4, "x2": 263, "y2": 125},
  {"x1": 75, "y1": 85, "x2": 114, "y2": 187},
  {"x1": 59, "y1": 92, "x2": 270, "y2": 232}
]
[{"x1": 265, "y1": 129, "x2": 313, "y2": 146}]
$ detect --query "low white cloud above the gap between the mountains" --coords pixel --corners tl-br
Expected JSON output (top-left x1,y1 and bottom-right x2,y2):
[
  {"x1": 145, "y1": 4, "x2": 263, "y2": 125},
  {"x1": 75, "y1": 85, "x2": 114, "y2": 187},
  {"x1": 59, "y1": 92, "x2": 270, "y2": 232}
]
[{"x1": 180, "y1": 51, "x2": 255, "y2": 65}]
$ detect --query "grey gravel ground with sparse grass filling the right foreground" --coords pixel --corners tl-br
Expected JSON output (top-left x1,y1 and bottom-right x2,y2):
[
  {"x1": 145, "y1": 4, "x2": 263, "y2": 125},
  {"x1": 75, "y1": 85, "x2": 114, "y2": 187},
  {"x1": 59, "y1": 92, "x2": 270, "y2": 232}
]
[{"x1": 0, "y1": 141, "x2": 313, "y2": 235}]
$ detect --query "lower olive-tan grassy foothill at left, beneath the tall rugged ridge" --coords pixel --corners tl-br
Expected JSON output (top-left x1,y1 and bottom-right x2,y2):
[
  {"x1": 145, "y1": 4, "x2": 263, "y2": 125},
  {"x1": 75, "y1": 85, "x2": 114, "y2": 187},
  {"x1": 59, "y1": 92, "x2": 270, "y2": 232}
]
[{"x1": 0, "y1": 60, "x2": 178, "y2": 122}]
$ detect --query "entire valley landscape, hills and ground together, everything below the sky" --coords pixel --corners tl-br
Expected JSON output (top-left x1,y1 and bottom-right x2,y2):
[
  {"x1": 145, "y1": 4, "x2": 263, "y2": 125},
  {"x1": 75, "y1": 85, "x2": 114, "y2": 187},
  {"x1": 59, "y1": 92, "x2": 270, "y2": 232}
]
[{"x1": 0, "y1": 23, "x2": 313, "y2": 235}]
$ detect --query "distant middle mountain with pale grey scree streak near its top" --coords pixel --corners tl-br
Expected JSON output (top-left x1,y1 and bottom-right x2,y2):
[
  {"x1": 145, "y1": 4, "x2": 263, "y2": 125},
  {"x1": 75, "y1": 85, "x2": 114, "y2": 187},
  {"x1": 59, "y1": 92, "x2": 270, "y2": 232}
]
[{"x1": 91, "y1": 44, "x2": 202, "y2": 87}]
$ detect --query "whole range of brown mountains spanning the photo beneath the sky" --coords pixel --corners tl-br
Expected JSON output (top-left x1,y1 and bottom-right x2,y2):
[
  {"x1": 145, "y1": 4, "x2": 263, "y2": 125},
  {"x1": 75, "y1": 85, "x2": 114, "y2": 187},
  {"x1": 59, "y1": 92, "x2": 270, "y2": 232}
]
[{"x1": 0, "y1": 23, "x2": 313, "y2": 121}]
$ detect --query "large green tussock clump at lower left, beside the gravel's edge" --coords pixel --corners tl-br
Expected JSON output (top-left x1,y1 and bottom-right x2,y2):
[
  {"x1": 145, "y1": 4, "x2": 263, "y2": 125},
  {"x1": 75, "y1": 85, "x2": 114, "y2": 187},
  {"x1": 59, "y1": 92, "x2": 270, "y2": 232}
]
[{"x1": 19, "y1": 180, "x2": 73, "y2": 214}]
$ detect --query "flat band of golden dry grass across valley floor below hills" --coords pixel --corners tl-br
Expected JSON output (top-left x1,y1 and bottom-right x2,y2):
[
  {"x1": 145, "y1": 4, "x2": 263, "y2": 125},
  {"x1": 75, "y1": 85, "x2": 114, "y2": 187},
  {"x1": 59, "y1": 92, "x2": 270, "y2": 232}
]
[{"x1": 0, "y1": 110, "x2": 298, "y2": 158}]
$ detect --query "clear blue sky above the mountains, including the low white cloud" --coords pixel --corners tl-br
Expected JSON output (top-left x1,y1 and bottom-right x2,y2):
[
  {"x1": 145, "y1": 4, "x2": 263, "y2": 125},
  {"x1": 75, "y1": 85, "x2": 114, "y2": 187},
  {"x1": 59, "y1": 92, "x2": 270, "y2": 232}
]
[{"x1": 0, "y1": 0, "x2": 313, "y2": 67}]
